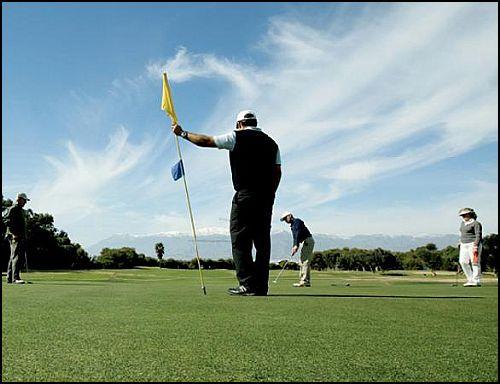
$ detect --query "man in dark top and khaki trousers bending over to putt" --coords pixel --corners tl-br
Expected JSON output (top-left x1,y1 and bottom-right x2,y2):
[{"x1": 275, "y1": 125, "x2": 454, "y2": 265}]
[{"x1": 280, "y1": 212, "x2": 314, "y2": 287}]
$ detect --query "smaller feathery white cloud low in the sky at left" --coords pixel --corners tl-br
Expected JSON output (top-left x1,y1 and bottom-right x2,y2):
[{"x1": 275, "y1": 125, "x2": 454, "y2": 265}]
[{"x1": 31, "y1": 127, "x2": 154, "y2": 220}]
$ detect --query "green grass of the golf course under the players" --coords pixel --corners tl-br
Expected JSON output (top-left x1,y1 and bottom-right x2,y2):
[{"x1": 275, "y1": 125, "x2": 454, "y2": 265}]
[{"x1": 2, "y1": 268, "x2": 498, "y2": 382}]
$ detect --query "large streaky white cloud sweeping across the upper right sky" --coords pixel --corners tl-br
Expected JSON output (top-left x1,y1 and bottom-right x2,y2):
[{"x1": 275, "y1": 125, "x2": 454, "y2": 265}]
[{"x1": 148, "y1": 4, "x2": 498, "y2": 204}]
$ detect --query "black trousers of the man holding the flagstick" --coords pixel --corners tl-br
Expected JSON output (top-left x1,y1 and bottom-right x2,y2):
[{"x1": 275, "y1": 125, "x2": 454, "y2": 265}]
[{"x1": 230, "y1": 191, "x2": 274, "y2": 294}]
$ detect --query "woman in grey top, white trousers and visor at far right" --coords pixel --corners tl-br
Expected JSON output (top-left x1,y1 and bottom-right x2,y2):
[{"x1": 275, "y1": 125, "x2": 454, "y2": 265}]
[{"x1": 458, "y1": 208, "x2": 483, "y2": 287}]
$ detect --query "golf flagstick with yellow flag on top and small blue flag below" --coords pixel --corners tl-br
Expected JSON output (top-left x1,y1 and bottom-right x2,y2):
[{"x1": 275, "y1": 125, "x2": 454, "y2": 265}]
[{"x1": 161, "y1": 73, "x2": 207, "y2": 295}]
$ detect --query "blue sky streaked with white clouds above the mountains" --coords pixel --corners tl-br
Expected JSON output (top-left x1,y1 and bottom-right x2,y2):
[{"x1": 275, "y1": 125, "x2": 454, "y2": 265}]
[{"x1": 2, "y1": 3, "x2": 498, "y2": 245}]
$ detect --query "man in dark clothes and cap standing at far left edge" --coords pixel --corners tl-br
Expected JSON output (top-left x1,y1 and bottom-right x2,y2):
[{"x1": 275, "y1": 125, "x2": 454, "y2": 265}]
[{"x1": 4, "y1": 193, "x2": 29, "y2": 284}]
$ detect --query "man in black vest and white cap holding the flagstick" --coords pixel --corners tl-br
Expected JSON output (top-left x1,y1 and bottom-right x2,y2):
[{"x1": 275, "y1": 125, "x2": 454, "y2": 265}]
[{"x1": 172, "y1": 110, "x2": 281, "y2": 296}]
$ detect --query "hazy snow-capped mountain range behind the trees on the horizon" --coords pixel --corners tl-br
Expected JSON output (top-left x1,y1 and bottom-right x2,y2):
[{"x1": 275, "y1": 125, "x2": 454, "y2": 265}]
[{"x1": 86, "y1": 231, "x2": 459, "y2": 261}]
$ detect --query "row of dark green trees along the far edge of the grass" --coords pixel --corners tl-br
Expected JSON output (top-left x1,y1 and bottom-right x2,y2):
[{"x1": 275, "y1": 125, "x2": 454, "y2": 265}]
[{"x1": 1, "y1": 197, "x2": 498, "y2": 273}]
